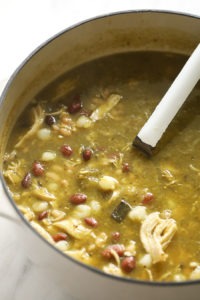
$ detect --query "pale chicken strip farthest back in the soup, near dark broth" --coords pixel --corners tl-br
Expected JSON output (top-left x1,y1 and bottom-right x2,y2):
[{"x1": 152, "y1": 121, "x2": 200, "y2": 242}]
[{"x1": 90, "y1": 94, "x2": 122, "y2": 122}]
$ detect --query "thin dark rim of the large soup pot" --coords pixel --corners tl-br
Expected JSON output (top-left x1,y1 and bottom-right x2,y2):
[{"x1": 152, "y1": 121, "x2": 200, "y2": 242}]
[{"x1": 0, "y1": 9, "x2": 200, "y2": 287}]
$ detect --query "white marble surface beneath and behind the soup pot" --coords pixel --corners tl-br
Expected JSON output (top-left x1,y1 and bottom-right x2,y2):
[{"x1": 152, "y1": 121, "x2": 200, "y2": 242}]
[{"x1": 0, "y1": 0, "x2": 200, "y2": 300}]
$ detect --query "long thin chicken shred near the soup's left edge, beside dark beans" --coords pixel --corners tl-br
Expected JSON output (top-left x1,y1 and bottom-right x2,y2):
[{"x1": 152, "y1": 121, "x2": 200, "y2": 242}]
[{"x1": 15, "y1": 105, "x2": 45, "y2": 148}]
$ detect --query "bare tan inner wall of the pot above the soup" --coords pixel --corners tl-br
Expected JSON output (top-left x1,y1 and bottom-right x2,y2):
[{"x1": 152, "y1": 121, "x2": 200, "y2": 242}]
[{"x1": 0, "y1": 11, "x2": 200, "y2": 158}]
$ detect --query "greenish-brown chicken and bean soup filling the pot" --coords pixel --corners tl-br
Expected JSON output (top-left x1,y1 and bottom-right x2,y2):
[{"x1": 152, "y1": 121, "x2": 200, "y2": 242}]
[{"x1": 4, "y1": 52, "x2": 200, "y2": 281}]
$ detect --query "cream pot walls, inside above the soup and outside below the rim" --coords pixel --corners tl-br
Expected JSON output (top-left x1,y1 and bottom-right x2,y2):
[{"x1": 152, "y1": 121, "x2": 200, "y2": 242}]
[{"x1": 0, "y1": 11, "x2": 200, "y2": 300}]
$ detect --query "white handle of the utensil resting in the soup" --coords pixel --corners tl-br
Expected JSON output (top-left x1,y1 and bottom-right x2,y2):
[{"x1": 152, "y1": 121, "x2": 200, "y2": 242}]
[{"x1": 137, "y1": 44, "x2": 200, "y2": 148}]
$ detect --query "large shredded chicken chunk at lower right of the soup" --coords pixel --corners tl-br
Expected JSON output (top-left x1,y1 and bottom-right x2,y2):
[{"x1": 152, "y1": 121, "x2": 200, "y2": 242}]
[{"x1": 140, "y1": 212, "x2": 177, "y2": 264}]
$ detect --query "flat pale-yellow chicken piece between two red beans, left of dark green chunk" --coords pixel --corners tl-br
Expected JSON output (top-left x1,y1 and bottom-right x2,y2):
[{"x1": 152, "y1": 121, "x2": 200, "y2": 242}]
[{"x1": 54, "y1": 218, "x2": 91, "y2": 240}]
